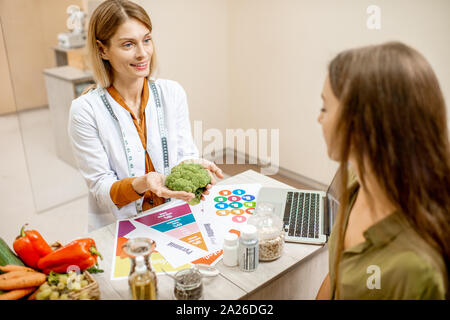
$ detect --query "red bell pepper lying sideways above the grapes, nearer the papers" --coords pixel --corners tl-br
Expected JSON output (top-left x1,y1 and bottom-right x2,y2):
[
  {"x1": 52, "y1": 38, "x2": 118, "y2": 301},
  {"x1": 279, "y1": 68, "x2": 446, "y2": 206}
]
[{"x1": 38, "y1": 238, "x2": 103, "y2": 274}]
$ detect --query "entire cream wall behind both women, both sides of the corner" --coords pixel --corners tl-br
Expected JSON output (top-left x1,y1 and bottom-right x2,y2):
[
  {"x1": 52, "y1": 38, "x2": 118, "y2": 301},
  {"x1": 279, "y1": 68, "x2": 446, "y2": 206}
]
[{"x1": 139, "y1": 0, "x2": 450, "y2": 184}]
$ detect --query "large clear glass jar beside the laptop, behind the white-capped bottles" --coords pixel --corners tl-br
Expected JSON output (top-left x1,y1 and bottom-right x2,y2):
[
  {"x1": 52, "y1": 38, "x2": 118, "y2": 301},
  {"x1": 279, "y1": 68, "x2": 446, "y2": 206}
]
[{"x1": 247, "y1": 202, "x2": 285, "y2": 261}]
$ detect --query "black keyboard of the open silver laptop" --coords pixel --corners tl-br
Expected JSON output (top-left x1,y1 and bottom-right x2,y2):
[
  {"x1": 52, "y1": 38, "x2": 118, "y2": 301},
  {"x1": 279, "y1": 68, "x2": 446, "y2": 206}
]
[{"x1": 283, "y1": 192, "x2": 320, "y2": 239}]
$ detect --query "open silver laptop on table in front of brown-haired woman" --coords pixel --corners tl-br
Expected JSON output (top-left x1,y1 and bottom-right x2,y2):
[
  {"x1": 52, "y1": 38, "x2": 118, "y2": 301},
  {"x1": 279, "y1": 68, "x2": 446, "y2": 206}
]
[{"x1": 256, "y1": 173, "x2": 339, "y2": 244}]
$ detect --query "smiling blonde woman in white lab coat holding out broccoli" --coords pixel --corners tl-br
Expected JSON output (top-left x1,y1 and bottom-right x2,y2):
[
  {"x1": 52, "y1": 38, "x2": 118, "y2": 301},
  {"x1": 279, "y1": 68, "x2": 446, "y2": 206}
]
[{"x1": 69, "y1": 0, "x2": 223, "y2": 230}]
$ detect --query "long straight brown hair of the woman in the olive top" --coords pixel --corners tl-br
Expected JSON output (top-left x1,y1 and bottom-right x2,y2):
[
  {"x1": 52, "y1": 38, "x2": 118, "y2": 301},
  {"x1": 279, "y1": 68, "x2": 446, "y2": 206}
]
[{"x1": 328, "y1": 42, "x2": 450, "y2": 297}]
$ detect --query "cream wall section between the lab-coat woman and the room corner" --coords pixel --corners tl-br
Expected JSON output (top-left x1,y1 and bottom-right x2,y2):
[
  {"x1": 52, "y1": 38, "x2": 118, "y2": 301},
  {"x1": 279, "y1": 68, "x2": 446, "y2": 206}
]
[{"x1": 136, "y1": 0, "x2": 230, "y2": 135}]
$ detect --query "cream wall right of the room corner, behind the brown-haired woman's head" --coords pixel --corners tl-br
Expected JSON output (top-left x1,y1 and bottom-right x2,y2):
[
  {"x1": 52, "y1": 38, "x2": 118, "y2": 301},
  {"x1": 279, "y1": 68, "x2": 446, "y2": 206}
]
[{"x1": 229, "y1": 0, "x2": 450, "y2": 183}]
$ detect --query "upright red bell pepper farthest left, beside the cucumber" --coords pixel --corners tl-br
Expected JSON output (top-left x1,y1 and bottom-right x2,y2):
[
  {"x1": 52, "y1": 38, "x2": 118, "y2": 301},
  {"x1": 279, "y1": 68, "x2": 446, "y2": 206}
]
[{"x1": 13, "y1": 224, "x2": 53, "y2": 269}]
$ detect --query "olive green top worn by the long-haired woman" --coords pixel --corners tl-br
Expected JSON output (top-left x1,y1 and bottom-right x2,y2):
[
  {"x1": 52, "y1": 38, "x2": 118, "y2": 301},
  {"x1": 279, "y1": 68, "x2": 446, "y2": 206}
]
[{"x1": 328, "y1": 182, "x2": 448, "y2": 300}]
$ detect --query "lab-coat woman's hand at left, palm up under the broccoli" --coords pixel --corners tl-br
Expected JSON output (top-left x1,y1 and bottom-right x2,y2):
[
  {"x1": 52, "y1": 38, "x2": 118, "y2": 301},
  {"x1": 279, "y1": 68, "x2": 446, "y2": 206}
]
[{"x1": 132, "y1": 172, "x2": 195, "y2": 201}]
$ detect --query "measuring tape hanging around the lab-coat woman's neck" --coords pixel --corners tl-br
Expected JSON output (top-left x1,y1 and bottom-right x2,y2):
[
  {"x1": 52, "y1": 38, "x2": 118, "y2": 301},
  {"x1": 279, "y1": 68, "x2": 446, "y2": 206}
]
[{"x1": 100, "y1": 81, "x2": 170, "y2": 215}]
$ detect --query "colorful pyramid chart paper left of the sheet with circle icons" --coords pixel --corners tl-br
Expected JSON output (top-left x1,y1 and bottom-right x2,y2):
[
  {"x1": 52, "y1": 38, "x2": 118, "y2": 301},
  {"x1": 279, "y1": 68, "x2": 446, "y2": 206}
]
[{"x1": 111, "y1": 202, "x2": 222, "y2": 279}]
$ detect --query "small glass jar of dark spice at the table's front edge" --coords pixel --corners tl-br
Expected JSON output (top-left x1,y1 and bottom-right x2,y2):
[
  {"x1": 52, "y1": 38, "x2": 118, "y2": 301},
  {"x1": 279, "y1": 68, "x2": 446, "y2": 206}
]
[{"x1": 173, "y1": 268, "x2": 203, "y2": 300}]
